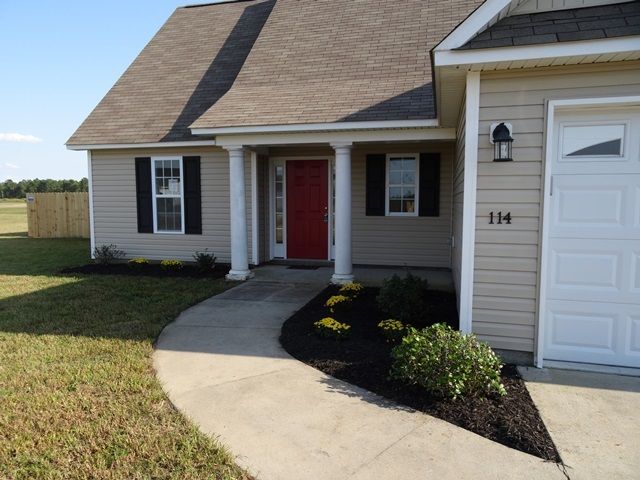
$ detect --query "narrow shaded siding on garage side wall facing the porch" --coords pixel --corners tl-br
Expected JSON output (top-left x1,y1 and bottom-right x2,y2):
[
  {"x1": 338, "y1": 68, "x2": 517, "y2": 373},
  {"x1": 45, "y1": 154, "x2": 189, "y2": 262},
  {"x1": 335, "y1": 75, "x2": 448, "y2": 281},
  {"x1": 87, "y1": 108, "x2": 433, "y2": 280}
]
[{"x1": 451, "y1": 100, "x2": 466, "y2": 312}]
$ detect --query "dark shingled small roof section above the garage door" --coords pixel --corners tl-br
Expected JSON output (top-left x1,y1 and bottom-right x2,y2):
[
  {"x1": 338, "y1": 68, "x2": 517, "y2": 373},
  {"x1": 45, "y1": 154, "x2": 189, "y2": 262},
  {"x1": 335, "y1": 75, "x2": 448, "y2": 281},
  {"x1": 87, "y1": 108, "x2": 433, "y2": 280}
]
[{"x1": 460, "y1": 1, "x2": 640, "y2": 49}]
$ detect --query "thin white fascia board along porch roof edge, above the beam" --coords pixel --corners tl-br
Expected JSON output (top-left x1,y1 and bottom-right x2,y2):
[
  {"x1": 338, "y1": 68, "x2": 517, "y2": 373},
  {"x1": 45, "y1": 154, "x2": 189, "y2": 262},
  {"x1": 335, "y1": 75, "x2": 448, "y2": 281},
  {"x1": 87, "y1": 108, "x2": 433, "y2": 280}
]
[{"x1": 191, "y1": 118, "x2": 438, "y2": 135}]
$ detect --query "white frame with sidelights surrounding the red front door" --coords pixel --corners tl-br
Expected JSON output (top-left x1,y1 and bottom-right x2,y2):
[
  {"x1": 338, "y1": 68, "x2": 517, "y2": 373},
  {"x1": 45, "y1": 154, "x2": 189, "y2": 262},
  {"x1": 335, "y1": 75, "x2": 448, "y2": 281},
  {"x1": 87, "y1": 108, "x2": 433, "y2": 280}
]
[{"x1": 269, "y1": 155, "x2": 336, "y2": 261}]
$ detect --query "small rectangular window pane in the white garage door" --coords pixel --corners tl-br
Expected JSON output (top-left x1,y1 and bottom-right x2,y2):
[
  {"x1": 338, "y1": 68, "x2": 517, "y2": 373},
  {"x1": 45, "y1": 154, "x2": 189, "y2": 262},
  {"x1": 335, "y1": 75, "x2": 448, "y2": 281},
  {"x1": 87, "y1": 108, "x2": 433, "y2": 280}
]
[{"x1": 562, "y1": 125, "x2": 625, "y2": 157}]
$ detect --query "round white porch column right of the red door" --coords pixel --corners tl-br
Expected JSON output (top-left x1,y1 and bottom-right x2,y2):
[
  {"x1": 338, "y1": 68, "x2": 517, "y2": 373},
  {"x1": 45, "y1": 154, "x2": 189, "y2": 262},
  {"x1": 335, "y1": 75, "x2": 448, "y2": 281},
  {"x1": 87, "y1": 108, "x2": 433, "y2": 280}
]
[{"x1": 331, "y1": 142, "x2": 353, "y2": 284}]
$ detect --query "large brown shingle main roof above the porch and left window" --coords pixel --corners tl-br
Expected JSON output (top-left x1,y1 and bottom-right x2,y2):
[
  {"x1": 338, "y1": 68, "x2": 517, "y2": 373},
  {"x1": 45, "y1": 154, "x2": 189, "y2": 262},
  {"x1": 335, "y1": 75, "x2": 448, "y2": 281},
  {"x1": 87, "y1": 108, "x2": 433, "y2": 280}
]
[{"x1": 68, "y1": 0, "x2": 483, "y2": 145}]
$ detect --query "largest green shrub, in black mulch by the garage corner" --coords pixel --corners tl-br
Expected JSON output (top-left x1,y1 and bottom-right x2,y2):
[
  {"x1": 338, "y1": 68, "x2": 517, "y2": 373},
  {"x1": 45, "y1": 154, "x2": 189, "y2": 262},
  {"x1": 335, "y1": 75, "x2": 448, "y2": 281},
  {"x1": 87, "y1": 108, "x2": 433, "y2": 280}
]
[{"x1": 391, "y1": 323, "x2": 506, "y2": 398}]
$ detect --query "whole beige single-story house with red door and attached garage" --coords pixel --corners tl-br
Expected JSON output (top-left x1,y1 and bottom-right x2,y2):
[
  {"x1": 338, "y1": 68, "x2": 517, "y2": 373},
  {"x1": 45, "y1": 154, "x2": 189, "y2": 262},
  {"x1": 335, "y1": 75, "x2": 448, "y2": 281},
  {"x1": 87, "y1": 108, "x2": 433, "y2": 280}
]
[{"x1": 67, "y1": 0, "x2": 640, "y2": 368}]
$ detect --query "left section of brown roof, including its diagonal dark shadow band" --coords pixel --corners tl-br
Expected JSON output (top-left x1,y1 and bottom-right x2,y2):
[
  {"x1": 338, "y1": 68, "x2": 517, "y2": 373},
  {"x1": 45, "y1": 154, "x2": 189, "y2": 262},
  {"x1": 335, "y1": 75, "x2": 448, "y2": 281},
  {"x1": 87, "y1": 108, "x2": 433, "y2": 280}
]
[{"x1": 67, "y1": 0, "x2": 275, "y2": 145}]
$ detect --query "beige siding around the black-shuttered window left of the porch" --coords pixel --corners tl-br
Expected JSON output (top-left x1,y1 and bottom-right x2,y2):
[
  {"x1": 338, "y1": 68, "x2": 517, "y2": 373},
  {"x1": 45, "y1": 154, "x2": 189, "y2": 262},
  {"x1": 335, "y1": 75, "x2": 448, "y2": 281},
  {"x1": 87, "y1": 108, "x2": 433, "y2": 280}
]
[{"x1": 91, "y1": 147, "x2": 251, "y2": 262}]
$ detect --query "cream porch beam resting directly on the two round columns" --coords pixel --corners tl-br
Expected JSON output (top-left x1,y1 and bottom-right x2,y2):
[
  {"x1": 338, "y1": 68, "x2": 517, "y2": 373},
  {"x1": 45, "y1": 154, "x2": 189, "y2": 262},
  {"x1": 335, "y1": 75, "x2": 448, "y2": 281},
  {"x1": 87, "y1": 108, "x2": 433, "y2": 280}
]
[{"x1": 216, "y1": 128, "x2": 456, "y2": 148}]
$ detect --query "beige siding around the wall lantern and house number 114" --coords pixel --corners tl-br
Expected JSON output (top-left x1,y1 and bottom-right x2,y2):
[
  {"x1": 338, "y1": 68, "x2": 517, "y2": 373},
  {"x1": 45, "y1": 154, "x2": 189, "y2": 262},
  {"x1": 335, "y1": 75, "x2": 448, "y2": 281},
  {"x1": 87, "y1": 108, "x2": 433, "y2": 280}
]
[{"x1": 473, "y1": 63, "x2": 640, "y2": 352}]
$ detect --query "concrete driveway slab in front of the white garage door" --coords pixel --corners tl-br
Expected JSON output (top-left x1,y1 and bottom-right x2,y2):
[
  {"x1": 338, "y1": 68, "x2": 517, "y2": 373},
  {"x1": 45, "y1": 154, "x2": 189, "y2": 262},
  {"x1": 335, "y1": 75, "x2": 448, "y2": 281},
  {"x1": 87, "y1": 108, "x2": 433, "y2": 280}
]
[{"x1": 520, "y1": 368, "x2": 640, "y2": 480}]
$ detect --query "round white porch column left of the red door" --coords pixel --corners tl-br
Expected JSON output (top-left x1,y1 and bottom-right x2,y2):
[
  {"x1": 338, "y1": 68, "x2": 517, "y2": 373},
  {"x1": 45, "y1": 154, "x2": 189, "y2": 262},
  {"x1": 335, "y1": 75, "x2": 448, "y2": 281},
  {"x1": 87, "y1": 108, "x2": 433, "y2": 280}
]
[{"x1": 225, "y1": 145, "x2": 253, "y2": 281}]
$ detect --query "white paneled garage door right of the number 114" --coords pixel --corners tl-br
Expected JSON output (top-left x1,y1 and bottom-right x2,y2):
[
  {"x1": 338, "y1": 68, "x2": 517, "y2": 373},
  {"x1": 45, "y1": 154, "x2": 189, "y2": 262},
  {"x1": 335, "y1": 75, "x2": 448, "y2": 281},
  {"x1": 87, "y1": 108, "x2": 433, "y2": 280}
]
[{"x1": 544, "y1": 107, "x2": 640, "y2": 367}]
